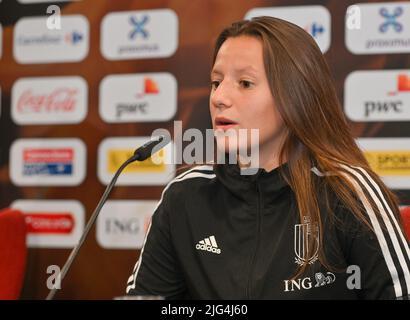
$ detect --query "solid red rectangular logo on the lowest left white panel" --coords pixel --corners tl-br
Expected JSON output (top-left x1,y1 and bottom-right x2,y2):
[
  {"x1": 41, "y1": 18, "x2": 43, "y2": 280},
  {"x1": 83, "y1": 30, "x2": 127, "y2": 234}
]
[{"x1": 25, "y1": 212, "x2": 74, "y2": 234}]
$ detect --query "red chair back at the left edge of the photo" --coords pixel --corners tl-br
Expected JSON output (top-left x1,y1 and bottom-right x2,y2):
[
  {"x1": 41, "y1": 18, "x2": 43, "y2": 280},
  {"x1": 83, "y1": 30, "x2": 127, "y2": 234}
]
[{"x1": 0, "y1": 209, "x2": 27, "y2": 300}]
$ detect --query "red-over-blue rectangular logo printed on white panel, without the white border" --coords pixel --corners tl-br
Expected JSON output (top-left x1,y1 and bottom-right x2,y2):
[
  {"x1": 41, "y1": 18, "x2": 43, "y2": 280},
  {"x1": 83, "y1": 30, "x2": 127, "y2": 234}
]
[{"x1": 23, "y1": 148, "x2": 74, "y2": 176}]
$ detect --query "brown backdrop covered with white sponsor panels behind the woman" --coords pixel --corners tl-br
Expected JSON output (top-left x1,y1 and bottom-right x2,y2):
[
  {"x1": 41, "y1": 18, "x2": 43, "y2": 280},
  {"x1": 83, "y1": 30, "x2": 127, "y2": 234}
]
[{"x1": 0, "y1": 0, "x2": 410, "y2": 299}]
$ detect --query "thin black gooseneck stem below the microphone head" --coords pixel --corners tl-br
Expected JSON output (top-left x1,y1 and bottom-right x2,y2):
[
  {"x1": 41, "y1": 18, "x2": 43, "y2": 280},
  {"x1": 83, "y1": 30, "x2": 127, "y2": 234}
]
[{"x1": 46, "y1": 152, "x2": 141, "y2": 300}]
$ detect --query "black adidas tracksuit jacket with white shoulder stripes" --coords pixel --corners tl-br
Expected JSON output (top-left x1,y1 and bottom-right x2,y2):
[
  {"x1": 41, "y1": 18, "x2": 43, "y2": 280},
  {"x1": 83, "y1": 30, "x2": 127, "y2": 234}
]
[{"x1": 127, "y1": 164, "x2": 410, "y2": 299}]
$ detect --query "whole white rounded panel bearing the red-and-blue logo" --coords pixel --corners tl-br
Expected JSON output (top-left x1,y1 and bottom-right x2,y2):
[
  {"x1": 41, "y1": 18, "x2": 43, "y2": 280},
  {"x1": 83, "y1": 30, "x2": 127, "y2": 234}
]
[{"x1": 10, "y1": 139, "x2": 86, "y2": 186}]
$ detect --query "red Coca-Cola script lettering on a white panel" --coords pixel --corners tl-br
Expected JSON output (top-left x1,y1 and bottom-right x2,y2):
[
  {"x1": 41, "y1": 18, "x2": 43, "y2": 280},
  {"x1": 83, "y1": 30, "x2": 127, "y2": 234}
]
[{"x1": 17, "y1": 87, "x2": 78, "y2": 113}]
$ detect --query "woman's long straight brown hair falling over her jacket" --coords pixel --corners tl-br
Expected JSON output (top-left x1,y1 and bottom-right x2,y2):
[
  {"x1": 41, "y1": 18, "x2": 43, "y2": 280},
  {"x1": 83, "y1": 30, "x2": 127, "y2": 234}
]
[{"x1": 212, "y1": 17, "x2": 401, "y2": 277}]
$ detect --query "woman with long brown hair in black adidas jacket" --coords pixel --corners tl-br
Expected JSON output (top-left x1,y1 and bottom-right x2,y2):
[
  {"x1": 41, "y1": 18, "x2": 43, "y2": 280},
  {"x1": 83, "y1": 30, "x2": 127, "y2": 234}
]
[{"x1": 127, "y1": 17, "x2": 410, "y2": 299}]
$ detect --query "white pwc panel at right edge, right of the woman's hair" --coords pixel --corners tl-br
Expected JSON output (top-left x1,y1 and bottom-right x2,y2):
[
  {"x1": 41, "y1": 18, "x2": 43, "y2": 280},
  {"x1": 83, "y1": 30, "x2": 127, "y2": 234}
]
[{"x1": 344, "y1": 70, "x2": 410, "y2": 121}]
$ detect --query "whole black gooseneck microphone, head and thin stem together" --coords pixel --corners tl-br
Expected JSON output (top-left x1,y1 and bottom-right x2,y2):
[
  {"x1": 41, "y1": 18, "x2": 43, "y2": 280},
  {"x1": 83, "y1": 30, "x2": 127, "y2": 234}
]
[{"x1": 46, "y1": 135, "x2": 170, "y2": 300}]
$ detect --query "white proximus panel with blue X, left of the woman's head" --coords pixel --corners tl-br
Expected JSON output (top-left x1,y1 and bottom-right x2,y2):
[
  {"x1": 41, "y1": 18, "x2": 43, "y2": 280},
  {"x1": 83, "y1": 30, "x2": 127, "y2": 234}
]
[{"x1": 101, "y1": 9, "x2": 178, "y2": 60}]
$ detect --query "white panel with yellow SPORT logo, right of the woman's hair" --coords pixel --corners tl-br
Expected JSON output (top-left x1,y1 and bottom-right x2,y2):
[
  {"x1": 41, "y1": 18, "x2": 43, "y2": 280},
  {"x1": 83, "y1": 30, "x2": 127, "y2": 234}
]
[{"x1": 357, "y1": 138, "x2": 410, "y2": 189}]
